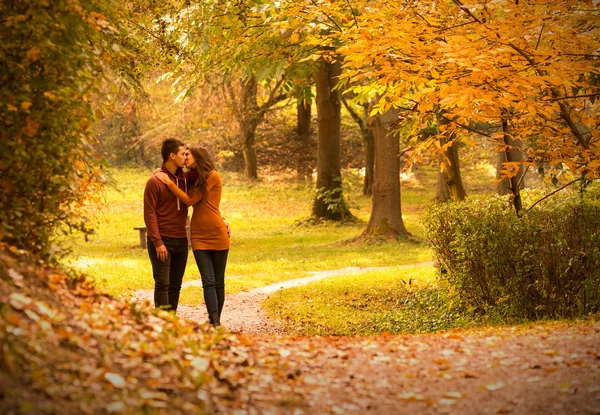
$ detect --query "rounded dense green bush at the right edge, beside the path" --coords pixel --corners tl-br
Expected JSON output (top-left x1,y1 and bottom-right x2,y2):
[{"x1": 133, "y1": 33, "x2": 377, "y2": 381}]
[{"x1": 423, "y1": 196, "x2": 600, "y2": 319}]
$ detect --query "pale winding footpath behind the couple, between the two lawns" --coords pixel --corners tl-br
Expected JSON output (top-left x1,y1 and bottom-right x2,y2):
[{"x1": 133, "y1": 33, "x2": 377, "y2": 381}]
[{"x1": 133, "y1": 262, "x2": 432, "y2": 334}]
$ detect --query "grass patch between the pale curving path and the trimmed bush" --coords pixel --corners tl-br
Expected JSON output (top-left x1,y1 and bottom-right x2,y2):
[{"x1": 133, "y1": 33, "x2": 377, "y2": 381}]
[{"x1": 264, "y1": 265, "x2": 481, "y2": 336}]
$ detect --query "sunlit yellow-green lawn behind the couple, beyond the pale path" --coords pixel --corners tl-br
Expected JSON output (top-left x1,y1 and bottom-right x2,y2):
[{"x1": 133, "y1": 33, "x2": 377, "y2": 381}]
[{"x1": 63, "y1": 169, "x2": 431, "y2": 304}]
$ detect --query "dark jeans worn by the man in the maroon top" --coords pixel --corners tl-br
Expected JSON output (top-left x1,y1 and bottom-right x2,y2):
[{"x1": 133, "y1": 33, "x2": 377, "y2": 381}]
[{"x1": 148, "y1": 237, "x2": 188, "y2": 311}]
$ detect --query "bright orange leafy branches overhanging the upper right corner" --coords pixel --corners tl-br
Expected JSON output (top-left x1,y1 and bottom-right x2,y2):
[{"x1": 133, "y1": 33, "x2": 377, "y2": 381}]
[{"x1": 340, "y1": 0, "x2": 600, "y2": 210}]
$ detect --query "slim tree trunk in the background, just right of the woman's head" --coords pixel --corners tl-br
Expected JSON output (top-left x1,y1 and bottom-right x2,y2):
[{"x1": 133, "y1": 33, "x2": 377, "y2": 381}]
[{"x1": 240, "y1": 77, "x2": 262, "y2": 179}]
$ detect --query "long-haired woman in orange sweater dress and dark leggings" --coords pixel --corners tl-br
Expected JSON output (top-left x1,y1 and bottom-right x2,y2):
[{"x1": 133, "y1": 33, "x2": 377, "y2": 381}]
[{"x1": 155, "y1": 147, "x2": 229, "y2": 326}]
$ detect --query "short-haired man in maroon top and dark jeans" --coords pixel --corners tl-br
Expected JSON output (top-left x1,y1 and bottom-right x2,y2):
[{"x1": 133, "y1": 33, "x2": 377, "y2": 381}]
[{"x1": 144, "y1": 138, "x2": 188, "y2": 312}]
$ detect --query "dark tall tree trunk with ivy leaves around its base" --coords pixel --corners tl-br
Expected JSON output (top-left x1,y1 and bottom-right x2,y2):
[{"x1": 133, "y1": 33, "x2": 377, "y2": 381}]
[{"x1": 312, "y1": 59, "x2": 351, "y2": 220}]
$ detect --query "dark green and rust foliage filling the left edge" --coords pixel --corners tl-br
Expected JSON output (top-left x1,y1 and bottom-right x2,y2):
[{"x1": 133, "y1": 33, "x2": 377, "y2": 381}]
[{"x1": 0, "y1": 0, "x2": 120, "y2": 255}]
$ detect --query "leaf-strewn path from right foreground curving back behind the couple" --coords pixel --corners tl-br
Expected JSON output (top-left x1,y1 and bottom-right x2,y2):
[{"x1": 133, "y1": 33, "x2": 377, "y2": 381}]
[{"x1": 125, "y1": 264, "x2": 600, "y2": 414}]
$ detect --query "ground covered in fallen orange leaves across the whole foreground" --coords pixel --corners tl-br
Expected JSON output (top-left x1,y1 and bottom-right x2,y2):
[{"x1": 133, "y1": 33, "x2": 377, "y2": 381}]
[{"x1": 0, "y1": 251, "x2": 600, "y2": 415}]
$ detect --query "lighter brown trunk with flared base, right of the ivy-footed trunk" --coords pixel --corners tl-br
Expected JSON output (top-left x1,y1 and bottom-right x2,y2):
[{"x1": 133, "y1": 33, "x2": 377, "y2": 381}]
[{"x1": 365, "y1": 109, "x2": 410, "y2": 238}]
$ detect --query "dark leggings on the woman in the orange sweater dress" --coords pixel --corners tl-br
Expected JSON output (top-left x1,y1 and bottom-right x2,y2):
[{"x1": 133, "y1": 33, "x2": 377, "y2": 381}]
[{"x1": 194, "y1": 249, "x2": 229, "y2": 317}]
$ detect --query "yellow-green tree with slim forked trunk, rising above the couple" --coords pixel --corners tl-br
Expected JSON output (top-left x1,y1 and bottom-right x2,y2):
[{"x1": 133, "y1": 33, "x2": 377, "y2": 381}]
[{"x1": 138, "y1": 0, "x2": 312, "y2": 178}]
